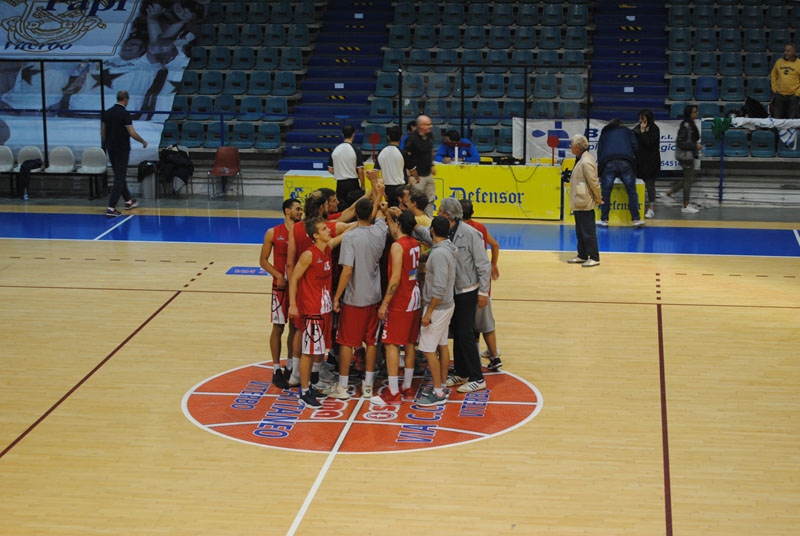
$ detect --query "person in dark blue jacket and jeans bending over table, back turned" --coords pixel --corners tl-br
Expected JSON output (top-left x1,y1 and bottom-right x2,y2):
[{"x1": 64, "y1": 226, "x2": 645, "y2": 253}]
[{"x1": 597, "y1": 119, "x2": 645, "y2": 227}]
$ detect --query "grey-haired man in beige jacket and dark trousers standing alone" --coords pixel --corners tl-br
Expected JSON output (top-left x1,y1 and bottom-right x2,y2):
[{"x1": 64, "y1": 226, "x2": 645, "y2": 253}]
[{"x1": 567, "y1": 134, "x2": 603, "y2": 268}]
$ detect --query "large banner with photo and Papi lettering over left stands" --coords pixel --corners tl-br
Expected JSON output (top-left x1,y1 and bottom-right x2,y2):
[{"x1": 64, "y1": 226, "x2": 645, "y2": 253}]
[{"x1": 0, "y1": 0, "x2": 205, "y2": 164}]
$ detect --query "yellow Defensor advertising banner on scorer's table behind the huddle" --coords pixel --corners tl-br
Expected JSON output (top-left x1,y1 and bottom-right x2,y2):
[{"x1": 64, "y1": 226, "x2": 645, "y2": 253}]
[{"x1": 283, "y1": 164, "x2": 561, "y2": 220}]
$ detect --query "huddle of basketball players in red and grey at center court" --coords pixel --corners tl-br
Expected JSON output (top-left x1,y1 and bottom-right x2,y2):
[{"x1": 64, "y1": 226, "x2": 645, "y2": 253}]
[{"x1": 260, "y1": 179, "x2": 502, "y2": 407}]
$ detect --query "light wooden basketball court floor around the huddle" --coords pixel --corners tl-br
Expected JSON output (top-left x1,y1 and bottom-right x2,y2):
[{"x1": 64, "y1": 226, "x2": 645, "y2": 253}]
[{"x1": 0, "y1": 206, "x2": 800, "y2": 536}]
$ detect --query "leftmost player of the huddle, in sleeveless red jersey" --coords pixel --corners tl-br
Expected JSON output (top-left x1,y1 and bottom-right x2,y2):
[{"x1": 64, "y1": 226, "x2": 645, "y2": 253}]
[{"x1": 259, "y1": 199, "x2": 303, "y2": 389}]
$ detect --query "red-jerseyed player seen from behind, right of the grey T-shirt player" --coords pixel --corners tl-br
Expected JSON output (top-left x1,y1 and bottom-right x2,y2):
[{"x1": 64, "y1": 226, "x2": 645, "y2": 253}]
[{"x1": 371, "y1": 210, "x2": 422, "y2": 405}]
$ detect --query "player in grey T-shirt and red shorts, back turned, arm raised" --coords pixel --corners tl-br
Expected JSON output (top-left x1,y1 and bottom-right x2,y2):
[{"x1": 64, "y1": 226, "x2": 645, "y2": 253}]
[{"x1": 326, "y1": 191, "x2": 388, "y2": 400}]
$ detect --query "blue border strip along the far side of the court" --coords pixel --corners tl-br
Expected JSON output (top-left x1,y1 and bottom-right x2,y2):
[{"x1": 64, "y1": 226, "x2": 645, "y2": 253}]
[{"x1": 0, "y1": 212, "x2": 800, "y2": 257}]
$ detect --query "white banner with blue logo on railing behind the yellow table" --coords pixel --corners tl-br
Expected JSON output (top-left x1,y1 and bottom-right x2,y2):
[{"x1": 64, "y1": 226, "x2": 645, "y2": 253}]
[{"x1": 513, "y1": 117, "x2": 681, "y2": 170}]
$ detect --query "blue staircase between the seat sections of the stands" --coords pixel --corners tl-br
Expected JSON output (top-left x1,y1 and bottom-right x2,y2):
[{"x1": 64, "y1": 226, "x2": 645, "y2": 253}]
[{"x1": 278, "y1": 0, "x2": 392, "y2": 171}]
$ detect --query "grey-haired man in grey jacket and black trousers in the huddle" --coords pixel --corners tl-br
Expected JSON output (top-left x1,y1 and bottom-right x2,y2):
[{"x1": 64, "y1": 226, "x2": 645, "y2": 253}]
[{"x1": 414, "y1": 197, "x2": 492, "y2": 393}]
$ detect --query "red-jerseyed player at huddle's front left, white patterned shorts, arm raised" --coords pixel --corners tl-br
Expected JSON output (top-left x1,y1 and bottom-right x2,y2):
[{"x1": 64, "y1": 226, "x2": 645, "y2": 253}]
[{"x1": 289, "y1": 218, "x2": 343, "y2": 408}]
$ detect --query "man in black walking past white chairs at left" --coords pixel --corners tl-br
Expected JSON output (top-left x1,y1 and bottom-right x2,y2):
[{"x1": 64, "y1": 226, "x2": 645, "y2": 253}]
[{"x1": 100, "y1": 91, "x2": 147, "y2": 218}]
